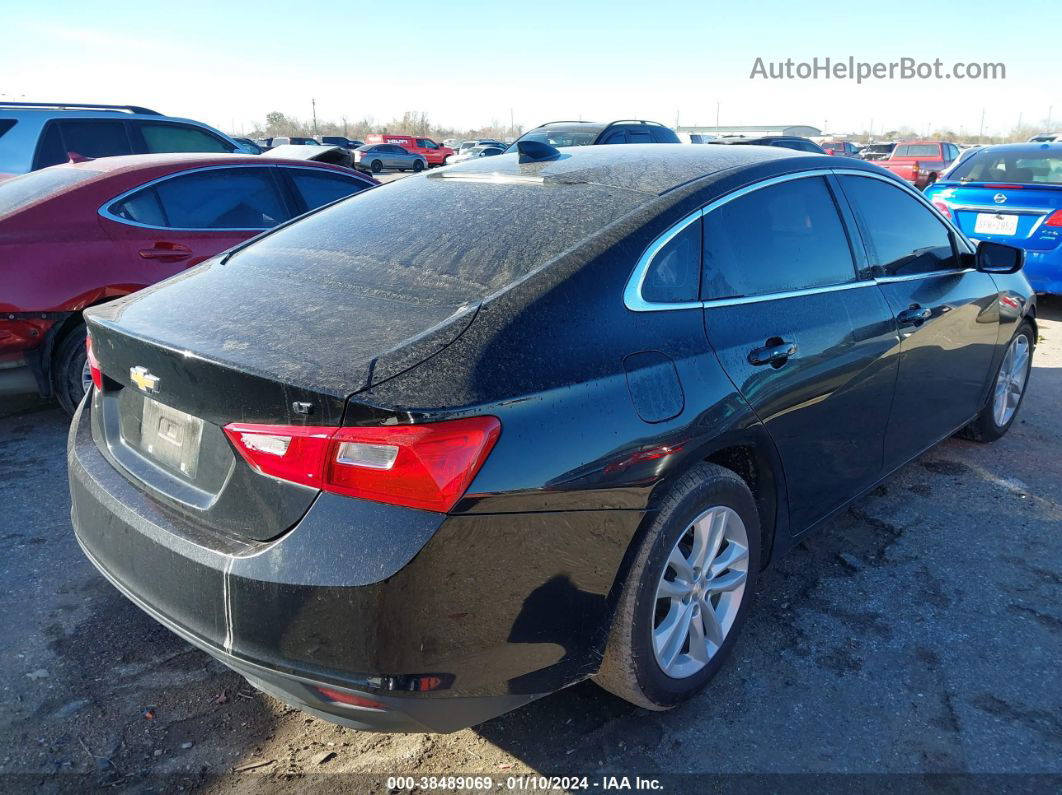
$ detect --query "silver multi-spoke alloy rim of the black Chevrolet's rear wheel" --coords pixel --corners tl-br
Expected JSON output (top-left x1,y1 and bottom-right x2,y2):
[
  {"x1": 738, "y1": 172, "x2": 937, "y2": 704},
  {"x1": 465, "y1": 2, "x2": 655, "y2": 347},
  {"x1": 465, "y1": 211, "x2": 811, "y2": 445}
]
[{"x1": 652, "y1": 505, "x2": 749, "y2": 679}]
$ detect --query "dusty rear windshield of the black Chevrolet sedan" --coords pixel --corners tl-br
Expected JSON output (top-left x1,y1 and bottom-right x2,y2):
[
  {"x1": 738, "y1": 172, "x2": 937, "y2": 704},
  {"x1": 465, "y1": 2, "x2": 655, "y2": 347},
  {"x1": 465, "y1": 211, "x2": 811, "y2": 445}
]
[{"x1": 228, "y1": 171, "x2": 648, "y2": 305}]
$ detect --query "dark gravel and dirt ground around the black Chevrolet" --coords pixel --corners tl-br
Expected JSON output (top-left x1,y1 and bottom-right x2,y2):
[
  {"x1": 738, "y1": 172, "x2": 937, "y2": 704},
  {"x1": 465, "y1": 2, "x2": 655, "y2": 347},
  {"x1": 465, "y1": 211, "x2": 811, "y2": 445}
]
[{"x1": 0, "y1": 300, "x2": 1062, "y2": 792}]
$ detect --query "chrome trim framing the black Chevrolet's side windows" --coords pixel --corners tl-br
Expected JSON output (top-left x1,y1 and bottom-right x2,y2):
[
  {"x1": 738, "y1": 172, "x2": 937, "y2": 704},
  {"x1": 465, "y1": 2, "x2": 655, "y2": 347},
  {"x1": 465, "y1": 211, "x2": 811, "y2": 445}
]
[{"x1": 623, "y1": 169, "x2": 974, "y2": 312}]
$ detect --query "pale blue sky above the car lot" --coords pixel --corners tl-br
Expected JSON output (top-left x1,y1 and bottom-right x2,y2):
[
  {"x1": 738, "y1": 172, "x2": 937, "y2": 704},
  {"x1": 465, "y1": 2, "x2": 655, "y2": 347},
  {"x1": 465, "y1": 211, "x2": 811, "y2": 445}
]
[{"x1": 0, "y1": 0, "x2": 1062, "y2": 135}]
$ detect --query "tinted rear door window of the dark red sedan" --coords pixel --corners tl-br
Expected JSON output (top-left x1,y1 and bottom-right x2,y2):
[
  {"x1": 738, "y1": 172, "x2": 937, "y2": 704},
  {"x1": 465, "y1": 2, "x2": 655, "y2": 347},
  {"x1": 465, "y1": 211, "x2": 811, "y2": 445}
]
[{"x1": 155, "y1": 168, "x2": 288, "y2": 229}]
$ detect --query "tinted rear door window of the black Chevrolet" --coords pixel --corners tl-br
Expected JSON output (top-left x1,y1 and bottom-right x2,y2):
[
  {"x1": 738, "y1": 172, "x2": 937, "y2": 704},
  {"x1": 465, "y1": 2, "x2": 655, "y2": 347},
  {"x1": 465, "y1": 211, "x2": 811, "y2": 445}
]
[{"x1": 701, "y1": 177, "x2": 855, "y2": 300}]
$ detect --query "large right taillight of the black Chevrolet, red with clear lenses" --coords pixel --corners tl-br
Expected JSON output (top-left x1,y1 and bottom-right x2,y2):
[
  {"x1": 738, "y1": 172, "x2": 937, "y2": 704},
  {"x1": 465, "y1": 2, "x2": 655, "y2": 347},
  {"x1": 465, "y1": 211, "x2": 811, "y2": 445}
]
[{"x1": 225, "y1": 417, "x2": 501, "y2": 513}]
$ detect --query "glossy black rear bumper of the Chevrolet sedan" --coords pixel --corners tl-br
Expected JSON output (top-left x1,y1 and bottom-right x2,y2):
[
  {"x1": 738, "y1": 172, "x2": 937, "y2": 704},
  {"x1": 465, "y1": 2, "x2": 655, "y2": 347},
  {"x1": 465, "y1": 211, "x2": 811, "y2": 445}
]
[{"x1": 68, "y1": 401, "x2": 641, "y2": 731}]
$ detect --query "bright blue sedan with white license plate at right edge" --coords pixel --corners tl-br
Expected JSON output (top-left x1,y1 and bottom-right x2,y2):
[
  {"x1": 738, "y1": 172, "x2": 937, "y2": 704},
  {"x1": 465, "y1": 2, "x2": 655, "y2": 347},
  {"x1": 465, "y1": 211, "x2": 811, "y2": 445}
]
[{"x1": 925, "y1": 143, "x2": 1062, "y2": 295}]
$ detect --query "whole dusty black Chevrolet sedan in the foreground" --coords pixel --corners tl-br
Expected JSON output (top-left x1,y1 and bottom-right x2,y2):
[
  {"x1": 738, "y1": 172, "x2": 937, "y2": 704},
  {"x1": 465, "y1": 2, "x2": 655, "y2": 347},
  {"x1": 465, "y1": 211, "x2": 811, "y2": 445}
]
[{"x1": 69, "y1": 144, "x2": 1037, "y2": 731}]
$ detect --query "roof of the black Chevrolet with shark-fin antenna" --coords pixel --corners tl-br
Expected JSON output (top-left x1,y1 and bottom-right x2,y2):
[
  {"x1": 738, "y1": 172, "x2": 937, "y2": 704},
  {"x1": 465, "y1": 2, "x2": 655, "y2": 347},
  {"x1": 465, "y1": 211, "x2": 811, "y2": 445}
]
[{"x1": 430, "y1": 143, "x2": 849, "y2": 195}]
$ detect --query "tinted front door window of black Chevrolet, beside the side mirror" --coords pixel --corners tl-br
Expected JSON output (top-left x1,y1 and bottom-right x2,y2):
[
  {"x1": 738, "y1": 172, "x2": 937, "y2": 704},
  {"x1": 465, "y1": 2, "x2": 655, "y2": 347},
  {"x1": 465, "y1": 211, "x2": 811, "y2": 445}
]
[{"x1": 841, "y1": 176, "x2": 958, "y2": 276}]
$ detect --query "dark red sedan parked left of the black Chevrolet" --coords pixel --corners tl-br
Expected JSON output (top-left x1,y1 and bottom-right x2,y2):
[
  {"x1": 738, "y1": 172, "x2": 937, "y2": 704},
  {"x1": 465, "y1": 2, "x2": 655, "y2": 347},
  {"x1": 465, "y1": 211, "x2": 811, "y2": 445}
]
[{"x1": 0, "y1": 153, "x2": 378, "y2": 413}]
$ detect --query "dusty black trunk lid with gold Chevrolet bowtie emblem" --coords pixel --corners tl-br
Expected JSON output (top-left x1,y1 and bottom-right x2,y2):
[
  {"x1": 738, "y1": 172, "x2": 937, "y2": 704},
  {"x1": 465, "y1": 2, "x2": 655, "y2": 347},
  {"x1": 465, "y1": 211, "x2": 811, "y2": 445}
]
[{"x1": 86, "y1": 261, "x2": 475, "y2": 540}]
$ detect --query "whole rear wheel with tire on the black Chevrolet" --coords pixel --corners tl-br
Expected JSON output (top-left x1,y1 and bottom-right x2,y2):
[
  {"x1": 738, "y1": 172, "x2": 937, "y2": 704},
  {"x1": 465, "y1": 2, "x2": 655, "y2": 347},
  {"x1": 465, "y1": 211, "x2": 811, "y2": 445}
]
[{"x1": 594, "y1": 464, "x2": 760, "y2": 710}]
